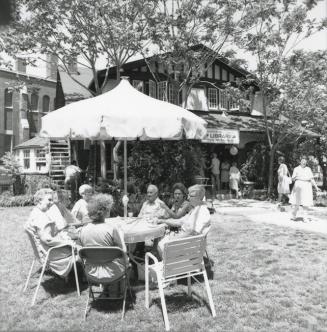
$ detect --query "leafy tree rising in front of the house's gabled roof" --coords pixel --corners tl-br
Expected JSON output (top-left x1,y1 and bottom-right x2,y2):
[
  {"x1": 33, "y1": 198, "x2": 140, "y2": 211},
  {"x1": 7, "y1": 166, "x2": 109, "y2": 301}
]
[{"x1": 144, "y1": 0, "x2": 248, "y2": 107}]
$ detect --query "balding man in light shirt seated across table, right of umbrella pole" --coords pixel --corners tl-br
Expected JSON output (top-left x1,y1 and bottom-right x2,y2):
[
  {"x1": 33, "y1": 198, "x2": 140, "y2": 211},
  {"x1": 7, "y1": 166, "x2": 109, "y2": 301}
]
[{"x1": 139, "y1": 184, "x2": 168, "y2": 218}]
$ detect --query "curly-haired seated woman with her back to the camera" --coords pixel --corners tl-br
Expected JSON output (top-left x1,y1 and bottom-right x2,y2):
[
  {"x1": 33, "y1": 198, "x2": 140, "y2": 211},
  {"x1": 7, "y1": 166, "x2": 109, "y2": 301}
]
[{"x1": 79, "y1": 194, "x2": 125, "y2": 281}]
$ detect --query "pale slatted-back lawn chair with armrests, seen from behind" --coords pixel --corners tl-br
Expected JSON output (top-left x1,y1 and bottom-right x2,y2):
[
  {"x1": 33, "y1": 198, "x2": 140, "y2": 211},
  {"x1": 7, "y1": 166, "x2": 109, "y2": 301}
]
[{"x1": 145, "y1": 235, "x2": 216, "y2": 331}]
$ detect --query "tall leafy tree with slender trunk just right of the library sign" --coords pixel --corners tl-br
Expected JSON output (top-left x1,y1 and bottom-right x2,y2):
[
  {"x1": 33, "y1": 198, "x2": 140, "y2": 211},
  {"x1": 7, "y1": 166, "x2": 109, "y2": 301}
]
[{"x1": 234, "y1": 0, "x2": 327, "y2": 194}]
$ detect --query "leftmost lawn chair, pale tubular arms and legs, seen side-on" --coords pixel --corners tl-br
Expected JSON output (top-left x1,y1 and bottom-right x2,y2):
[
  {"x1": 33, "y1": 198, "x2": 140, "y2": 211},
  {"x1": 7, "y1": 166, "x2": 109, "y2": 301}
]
[{"x1": 23, "y1": 230, "x2": 81, "y2": 306}]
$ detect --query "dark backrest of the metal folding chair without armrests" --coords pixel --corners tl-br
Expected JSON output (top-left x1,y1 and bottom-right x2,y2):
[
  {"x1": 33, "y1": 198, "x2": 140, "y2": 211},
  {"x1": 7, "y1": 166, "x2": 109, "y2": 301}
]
[{"x1": 78, "y1": 246, "x2": 126, "y2": 266}]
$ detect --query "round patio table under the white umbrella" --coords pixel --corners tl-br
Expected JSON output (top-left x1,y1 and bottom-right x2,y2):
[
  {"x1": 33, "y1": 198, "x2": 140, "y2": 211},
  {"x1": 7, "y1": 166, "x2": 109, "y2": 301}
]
[{"x1": 105, "y1": 217, "x2": 165, "y2": 244}]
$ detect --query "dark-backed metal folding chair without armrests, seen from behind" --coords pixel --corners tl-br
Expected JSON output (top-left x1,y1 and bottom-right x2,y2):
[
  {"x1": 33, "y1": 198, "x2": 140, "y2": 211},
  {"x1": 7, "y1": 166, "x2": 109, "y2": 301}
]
[{"x1": 79, "y1": 246, "x2": 131, "y2": 320}]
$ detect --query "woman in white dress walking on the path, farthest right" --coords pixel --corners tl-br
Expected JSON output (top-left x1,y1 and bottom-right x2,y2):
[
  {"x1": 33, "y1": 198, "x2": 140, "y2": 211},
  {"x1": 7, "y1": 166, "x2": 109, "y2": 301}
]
[{"x1": 290, "y1": 157, "x2": 320, "y2": 221}]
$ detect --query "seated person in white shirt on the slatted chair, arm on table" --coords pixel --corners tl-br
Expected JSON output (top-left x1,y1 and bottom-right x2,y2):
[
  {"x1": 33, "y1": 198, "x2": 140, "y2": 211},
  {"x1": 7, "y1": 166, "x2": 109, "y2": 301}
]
[{"x1": 158, "y1": 184, "x2": 210, "y2": 255}]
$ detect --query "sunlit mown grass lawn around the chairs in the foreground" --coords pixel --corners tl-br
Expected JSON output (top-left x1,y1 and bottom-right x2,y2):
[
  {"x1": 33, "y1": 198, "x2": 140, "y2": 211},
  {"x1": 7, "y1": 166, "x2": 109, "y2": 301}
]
[{"x1": 0, "y1": 207, "x2": 327, "y2": 332}]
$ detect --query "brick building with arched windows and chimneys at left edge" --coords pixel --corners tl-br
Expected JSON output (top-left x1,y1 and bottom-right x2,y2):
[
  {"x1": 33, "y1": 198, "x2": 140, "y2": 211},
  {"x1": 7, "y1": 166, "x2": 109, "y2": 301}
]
[{"x1": 0, "y1": 58, "x2": 57, "y2": 157}]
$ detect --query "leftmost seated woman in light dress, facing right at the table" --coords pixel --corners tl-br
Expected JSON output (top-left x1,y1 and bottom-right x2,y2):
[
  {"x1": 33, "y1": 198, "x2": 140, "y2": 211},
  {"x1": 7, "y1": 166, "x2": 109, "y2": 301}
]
[{"x1": 24, "y1": 188, "x2": 74, "y2": 277}]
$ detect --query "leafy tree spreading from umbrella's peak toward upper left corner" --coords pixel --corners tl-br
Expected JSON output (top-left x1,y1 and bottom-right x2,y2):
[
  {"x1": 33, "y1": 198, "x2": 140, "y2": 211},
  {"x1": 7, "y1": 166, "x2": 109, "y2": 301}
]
[{"x1": 2, "y1": 0, "x2": 156, "y2": 95}]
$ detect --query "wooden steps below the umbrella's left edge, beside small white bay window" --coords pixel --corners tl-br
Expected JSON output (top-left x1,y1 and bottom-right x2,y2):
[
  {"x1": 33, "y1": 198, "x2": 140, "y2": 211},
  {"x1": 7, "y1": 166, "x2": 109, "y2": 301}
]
[{"x1": 50, "y1": 139, "x2": 71, "y2": 189}]
